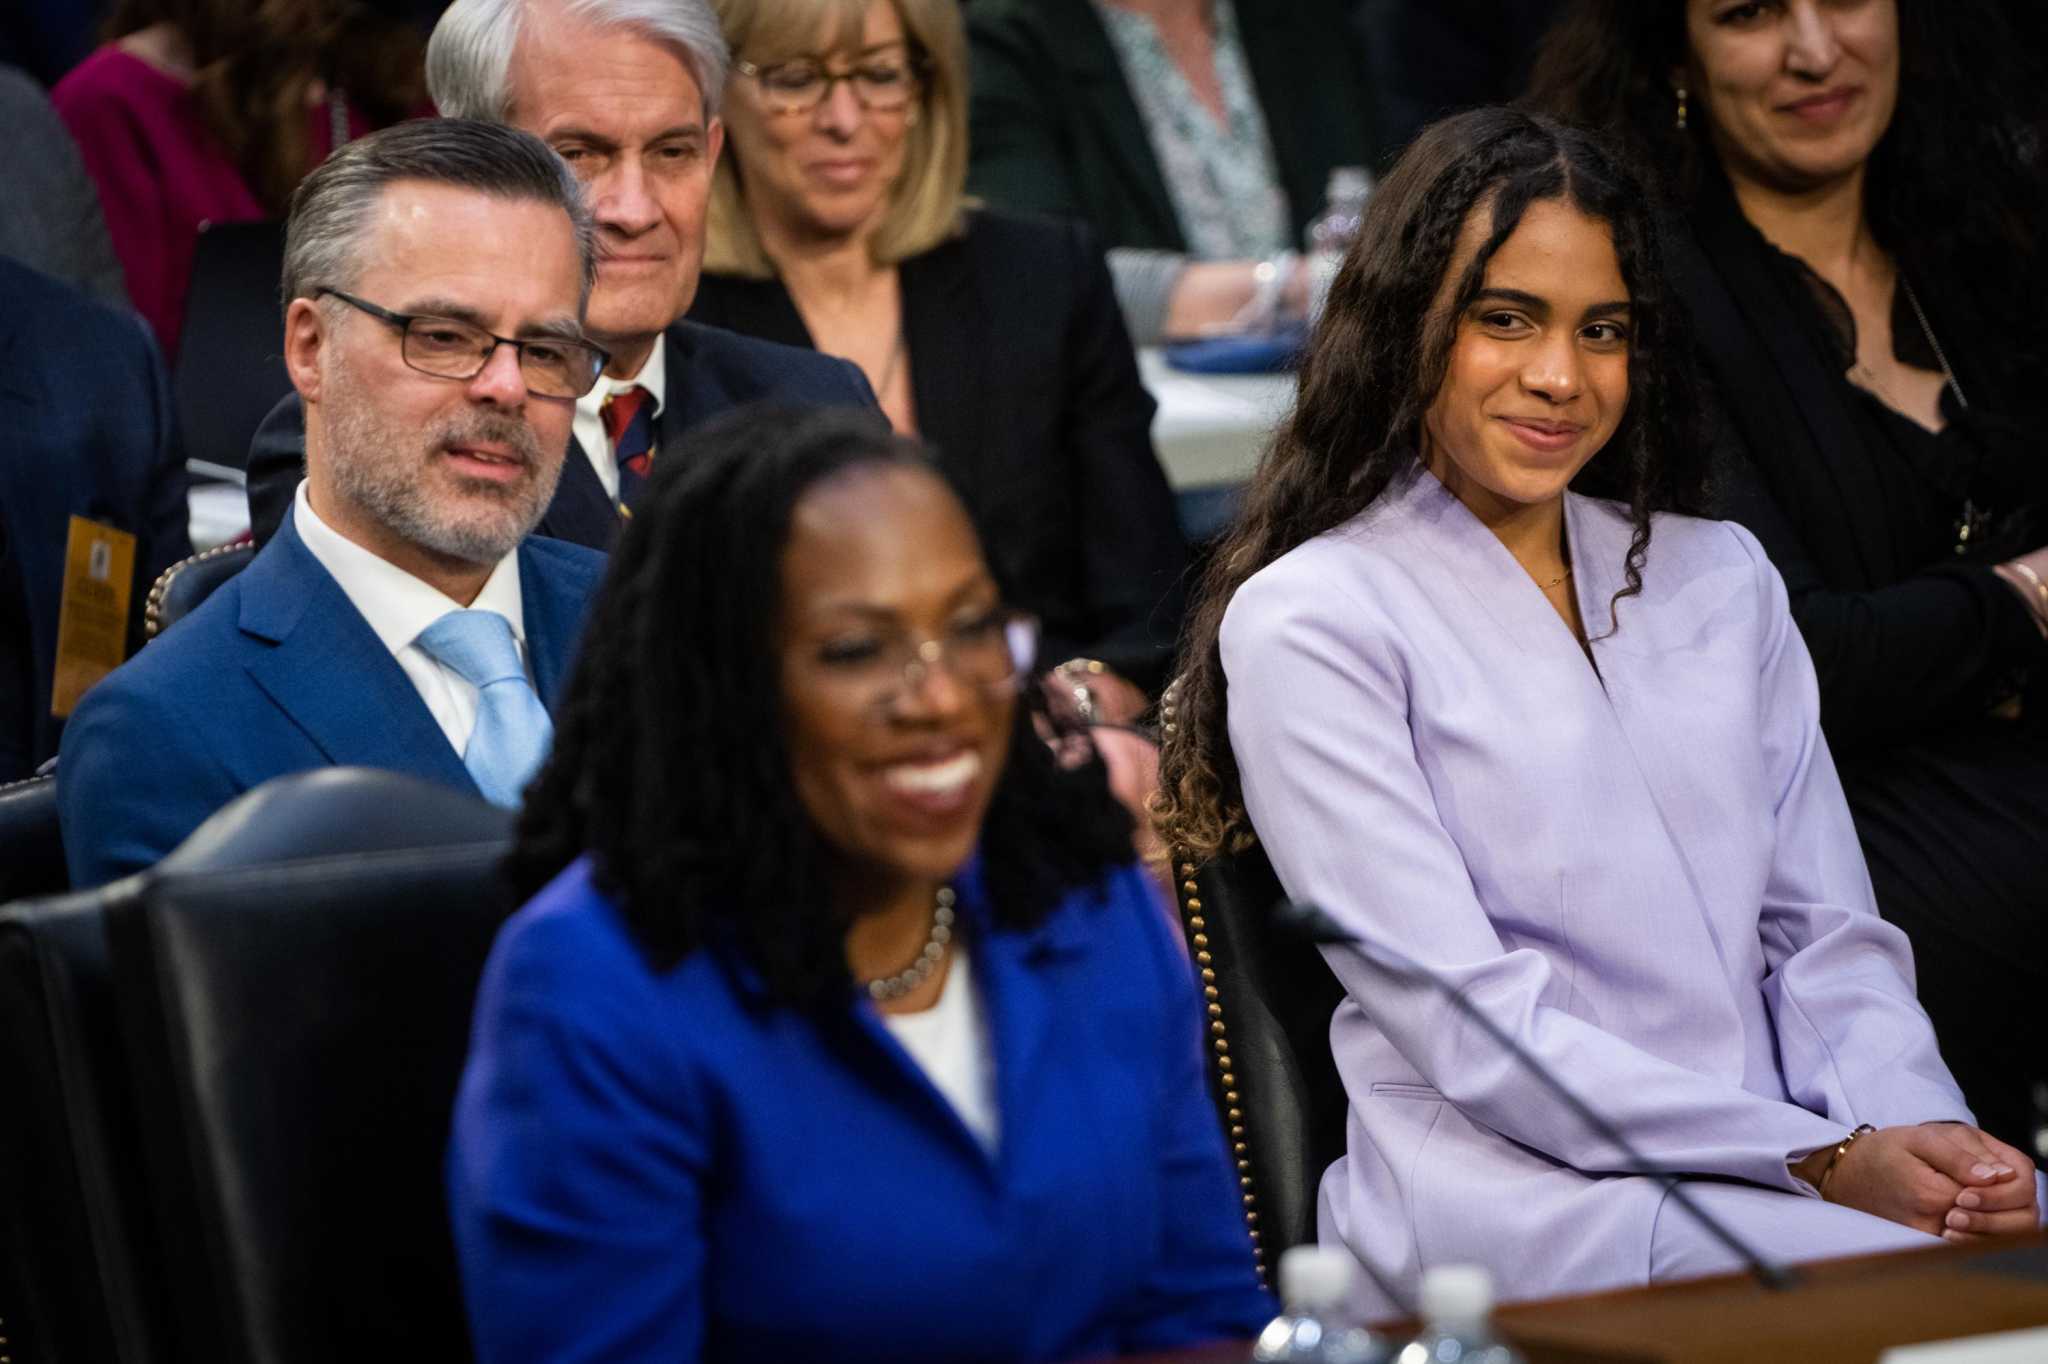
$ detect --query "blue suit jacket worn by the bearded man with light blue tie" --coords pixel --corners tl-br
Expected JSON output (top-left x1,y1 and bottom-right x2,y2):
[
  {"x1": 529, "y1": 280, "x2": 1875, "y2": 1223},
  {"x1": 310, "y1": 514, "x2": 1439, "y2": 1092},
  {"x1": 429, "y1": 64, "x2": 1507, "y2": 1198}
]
[{"x1": 57, "y1": 509, "x2": 604, "y2": 887}]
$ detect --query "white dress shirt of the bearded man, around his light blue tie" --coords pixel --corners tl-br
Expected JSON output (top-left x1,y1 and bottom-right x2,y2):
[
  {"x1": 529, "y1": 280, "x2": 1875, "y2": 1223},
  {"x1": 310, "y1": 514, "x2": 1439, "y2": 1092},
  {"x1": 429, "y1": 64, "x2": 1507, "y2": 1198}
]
[{"x1": 291, "y1": 481, "x2": 532, "y2": 754}]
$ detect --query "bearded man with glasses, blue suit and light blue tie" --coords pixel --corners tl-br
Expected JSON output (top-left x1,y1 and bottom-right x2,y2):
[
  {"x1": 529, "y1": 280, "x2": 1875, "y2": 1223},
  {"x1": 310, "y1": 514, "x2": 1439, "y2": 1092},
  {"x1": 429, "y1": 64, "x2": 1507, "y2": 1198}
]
[{"x1": 57, "y1": 119, "x2": 606, "y2": 885}]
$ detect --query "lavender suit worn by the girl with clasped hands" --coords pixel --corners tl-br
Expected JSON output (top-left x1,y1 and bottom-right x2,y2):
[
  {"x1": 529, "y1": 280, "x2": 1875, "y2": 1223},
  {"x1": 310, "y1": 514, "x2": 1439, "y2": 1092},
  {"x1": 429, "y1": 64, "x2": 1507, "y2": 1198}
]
[{"x1": 1223, "y1": 471, "x2": 1970, "y2": 1311}]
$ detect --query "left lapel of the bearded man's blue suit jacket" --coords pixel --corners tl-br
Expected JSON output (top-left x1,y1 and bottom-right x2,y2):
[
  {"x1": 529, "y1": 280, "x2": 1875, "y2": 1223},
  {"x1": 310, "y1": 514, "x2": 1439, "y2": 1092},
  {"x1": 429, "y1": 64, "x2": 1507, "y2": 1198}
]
[{"x1": 240, "y1": 514, "x2": 477, "y2": 791}]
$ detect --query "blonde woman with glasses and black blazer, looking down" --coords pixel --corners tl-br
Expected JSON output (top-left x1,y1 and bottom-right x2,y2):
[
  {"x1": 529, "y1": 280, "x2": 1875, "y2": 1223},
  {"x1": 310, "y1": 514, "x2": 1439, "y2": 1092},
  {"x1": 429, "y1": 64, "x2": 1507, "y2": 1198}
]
[{"x1": 690, "y1": 0, "x2": 1186, "y2": 721}]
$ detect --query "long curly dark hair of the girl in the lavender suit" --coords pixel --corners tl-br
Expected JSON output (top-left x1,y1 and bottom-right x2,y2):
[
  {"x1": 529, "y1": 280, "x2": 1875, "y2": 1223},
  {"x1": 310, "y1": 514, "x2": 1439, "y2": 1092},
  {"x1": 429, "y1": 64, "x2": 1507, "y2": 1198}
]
[{"x1": 1153, "y1": 109, "x2": 1706, "y2": 860}]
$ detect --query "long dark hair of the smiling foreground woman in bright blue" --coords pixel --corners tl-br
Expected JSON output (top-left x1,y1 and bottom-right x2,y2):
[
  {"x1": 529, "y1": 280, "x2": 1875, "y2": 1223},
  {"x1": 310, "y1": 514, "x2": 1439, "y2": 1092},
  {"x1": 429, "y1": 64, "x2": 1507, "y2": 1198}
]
[{"x1": 506, "y1": 406, "x2": 1133, "y2": 1004}]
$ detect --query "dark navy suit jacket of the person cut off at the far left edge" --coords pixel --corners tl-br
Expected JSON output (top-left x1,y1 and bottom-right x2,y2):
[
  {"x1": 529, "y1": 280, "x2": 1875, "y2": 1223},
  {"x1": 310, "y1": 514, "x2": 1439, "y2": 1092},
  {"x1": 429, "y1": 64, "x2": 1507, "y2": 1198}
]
[{"x1": 0, "y1": 260, "x2": 193, "y2": 782}]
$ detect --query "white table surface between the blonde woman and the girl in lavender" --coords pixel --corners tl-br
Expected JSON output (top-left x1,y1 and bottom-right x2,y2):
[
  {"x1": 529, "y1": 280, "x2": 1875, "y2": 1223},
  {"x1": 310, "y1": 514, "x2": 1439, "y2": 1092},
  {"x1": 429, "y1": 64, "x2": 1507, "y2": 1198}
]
[{"x1": 1139, "y1": 346, "x2": 1294, "y2": 492}]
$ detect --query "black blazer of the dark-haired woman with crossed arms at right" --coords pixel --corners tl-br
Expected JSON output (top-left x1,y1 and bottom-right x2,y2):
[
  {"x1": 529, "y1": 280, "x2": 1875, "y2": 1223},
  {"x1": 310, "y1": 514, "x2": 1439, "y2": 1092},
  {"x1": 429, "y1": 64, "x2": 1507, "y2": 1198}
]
[{"x1": 1671, "y1": 178, "x2": 2048, "y2": 754}]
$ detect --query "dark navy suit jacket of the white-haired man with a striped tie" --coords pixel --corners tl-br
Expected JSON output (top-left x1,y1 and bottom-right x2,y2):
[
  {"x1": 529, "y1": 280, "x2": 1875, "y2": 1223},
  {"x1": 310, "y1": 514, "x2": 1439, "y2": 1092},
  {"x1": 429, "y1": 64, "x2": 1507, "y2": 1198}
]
[{"x1": 248, "y1": 322, "x2": 874, "y2": 549}]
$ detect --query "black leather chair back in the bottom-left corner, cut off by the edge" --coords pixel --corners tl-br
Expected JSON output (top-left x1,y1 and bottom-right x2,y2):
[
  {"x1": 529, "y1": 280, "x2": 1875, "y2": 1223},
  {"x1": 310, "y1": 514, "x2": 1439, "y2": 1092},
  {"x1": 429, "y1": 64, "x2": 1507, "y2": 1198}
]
[{"x1": 0, "y1": 879, "x2": 174, "y2": 1364}]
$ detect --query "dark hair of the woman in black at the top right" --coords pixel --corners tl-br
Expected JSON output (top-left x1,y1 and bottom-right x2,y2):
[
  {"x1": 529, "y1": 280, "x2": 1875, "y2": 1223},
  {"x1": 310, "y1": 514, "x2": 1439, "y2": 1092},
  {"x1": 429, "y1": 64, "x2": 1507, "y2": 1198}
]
[{"x1": 1522, "y1": 0, "x2": 2048, "y2": 373}]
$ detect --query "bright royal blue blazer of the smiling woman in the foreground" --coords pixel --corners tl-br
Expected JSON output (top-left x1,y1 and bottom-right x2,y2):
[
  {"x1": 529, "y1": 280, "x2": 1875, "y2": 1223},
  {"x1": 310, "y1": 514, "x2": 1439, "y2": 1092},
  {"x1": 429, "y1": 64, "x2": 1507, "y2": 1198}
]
[{"x1": 449, "y1": 860, "x2": 1272, "y2": 1364}]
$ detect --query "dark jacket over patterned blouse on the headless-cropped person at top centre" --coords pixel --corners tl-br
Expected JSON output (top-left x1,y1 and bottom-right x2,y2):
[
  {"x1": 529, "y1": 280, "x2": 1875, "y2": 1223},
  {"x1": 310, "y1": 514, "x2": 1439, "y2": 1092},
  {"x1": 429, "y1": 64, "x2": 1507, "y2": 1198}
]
[{"x1": 967, "y1": 0, "x2": 1376, "y2": 252}]
